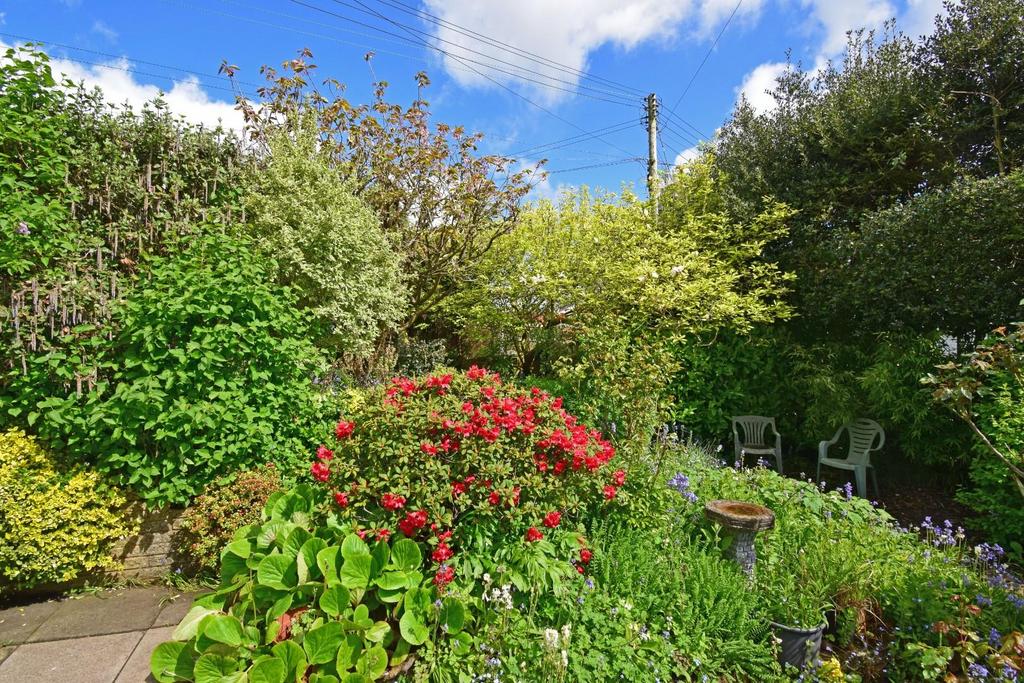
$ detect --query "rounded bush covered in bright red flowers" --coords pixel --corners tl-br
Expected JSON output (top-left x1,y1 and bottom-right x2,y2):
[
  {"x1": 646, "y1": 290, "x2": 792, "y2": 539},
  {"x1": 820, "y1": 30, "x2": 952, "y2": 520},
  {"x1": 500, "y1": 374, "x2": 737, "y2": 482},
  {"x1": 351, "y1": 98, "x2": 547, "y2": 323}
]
[{"x1": 310, "y1": 366, "x2": 627, "y2": 587}]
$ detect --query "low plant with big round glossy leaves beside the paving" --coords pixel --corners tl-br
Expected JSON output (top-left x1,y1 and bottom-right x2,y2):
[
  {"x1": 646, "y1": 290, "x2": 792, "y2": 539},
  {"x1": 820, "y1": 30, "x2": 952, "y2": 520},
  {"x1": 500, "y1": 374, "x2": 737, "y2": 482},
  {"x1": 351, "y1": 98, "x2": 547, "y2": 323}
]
[{"x1": 151, "y1": 484, "x2": 470, "y2": 683}]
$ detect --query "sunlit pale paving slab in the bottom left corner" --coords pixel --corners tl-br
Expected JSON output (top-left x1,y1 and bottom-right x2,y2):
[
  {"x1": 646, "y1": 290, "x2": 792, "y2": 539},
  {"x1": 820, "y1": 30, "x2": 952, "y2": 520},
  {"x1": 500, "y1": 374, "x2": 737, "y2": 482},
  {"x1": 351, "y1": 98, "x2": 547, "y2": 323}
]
[{"x1": 0, "y1": 631, "x2": 142, "y2": 683}]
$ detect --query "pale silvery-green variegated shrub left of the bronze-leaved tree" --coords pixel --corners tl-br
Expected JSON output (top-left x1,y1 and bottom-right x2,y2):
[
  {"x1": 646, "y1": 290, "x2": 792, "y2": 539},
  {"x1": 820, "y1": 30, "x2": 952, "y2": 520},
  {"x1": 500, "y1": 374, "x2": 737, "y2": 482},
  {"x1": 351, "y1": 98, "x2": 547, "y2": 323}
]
[{"x1": 245, "y1": 117, "x2": 406, "y2": 355}]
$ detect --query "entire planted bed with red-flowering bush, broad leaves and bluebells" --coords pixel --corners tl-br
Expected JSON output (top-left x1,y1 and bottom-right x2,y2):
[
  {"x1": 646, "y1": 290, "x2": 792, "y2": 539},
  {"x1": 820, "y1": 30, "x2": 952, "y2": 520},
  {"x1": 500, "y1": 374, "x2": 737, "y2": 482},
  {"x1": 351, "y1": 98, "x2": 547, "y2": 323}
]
[{"x1": 153, "y1": 368, "x2": 1024, "y2": 683}]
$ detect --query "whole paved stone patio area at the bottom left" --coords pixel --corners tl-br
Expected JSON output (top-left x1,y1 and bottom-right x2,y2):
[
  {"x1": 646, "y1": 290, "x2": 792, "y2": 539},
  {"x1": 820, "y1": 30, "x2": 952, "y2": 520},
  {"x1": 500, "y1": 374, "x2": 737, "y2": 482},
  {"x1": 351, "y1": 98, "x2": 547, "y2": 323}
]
[{"x1": 0, "y1": 588, "x2": 195, "y2": 683}]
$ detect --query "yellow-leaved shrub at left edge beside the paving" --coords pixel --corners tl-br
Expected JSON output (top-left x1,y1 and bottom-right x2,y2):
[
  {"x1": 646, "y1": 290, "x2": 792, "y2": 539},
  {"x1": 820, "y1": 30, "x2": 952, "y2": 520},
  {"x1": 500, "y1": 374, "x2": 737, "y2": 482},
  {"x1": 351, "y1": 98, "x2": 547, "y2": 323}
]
[{"x1": 0, "y1": 429, "x2": 134, "y2": 594}]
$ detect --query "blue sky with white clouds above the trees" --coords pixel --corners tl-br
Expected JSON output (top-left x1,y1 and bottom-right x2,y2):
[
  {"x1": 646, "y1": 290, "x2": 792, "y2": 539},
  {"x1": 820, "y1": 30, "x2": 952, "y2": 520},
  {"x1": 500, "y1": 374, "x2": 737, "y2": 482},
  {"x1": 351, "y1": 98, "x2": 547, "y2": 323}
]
[{"x1": 0, "y1": 0, "x2": 942, "y2": 196}]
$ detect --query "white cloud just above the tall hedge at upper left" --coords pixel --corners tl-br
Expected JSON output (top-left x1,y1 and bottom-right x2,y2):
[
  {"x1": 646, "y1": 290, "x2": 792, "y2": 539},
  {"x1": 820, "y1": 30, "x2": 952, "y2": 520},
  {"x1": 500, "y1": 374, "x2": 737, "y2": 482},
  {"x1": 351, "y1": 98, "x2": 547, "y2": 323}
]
[{"x1": 0, "y1": 41, "x2": 243, "y2": 131}]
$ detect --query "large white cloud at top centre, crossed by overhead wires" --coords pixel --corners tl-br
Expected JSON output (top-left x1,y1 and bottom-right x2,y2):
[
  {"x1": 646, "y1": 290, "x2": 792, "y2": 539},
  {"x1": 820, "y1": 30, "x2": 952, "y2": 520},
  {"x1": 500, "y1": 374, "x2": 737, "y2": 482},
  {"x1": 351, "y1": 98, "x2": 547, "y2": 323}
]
[{"x1": 425, "y1": 0, "x2": 765, "y2": 101}]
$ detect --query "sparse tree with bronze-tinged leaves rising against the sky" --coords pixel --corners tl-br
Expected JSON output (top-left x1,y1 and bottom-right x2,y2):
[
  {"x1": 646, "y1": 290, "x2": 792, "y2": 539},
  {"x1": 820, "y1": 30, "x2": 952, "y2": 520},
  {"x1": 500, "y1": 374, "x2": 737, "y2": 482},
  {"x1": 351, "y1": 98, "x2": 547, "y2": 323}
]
[{"x1": 233, "y1": 50, "x2": 531, "y2": 331}]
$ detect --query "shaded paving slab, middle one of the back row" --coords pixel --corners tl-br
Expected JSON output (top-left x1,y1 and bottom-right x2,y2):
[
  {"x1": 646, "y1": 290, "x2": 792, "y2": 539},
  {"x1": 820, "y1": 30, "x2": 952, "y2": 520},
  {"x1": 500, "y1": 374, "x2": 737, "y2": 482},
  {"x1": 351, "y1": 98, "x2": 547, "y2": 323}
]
[{"x1": 27, "y1": 588, "x2": 168, "y2": 643}]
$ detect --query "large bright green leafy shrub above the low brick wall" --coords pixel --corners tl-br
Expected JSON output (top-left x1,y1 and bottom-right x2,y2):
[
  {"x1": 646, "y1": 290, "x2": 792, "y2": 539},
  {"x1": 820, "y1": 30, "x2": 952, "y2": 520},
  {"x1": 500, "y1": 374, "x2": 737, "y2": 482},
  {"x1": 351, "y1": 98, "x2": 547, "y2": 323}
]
[{"x1": 29, "y1": 233, "x2": 318, "y2": 505}]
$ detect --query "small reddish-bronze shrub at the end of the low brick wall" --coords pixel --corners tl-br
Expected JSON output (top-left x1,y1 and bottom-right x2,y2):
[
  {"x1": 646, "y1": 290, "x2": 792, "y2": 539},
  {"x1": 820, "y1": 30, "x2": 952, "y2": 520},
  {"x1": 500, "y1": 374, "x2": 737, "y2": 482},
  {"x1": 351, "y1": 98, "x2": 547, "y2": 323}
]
[{"x1": 175, "y1": 465, "x2": 282, "y2": 573}]
